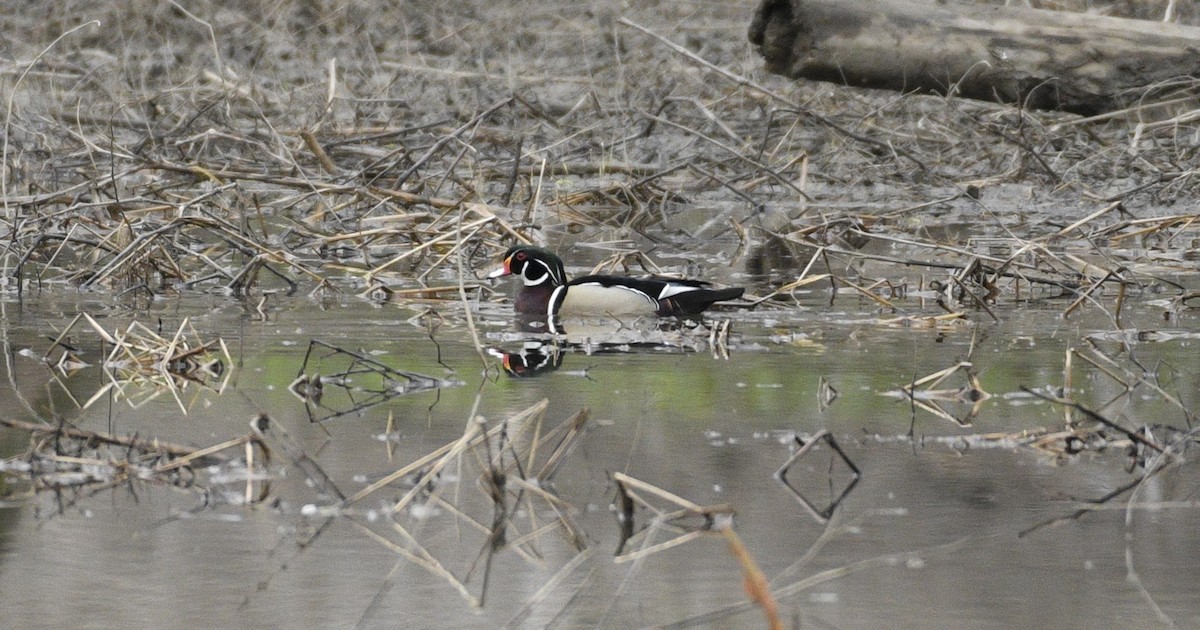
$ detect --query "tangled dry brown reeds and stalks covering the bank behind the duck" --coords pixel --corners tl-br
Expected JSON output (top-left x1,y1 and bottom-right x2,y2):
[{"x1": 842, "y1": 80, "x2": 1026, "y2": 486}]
[{"x1": 0, "y1": 1, "x2": 1200, "y2": 304}]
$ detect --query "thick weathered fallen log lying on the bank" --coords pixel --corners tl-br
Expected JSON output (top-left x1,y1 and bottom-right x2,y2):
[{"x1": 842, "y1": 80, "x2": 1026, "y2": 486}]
[{"x1": 749, "y1": 0, "x2": 1200, "y2": 115}]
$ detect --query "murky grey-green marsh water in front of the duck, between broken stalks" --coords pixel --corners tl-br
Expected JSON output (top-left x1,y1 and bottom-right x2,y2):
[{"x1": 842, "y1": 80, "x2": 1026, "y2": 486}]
[{"x1": 0, "y1": 285, "x2": 1200, "y2": 628}]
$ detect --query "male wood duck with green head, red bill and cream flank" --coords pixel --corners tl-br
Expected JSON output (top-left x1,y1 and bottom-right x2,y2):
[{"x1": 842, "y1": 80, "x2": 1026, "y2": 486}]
[{"x1": 487, "y1": 245, "x2": 745, "y2": 332}]
